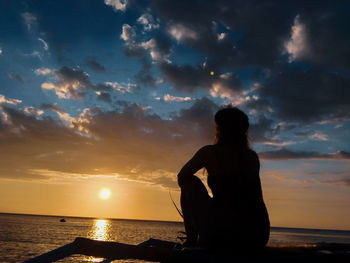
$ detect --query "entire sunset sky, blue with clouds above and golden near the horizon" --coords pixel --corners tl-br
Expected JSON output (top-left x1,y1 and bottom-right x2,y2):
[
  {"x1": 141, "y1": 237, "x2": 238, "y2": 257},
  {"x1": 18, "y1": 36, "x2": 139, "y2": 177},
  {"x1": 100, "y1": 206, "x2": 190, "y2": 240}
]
[{"x1": 0, "y1": 0, "x2": 350, "y2": 230}]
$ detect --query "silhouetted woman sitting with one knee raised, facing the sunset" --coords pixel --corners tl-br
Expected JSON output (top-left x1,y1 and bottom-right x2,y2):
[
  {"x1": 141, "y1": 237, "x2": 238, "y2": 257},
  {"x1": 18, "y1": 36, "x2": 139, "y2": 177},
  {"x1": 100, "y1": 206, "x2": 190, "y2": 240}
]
[{"x1": 178, "y1": 107, "x2": 270, "y2": 249}]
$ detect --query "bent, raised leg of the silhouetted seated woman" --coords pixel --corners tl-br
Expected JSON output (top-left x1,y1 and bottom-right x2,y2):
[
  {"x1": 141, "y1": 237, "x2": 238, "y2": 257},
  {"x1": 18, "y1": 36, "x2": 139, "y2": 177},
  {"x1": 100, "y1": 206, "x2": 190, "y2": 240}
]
[{"x1": 180, "y1": 176, "x2": 210, "y2": 245}]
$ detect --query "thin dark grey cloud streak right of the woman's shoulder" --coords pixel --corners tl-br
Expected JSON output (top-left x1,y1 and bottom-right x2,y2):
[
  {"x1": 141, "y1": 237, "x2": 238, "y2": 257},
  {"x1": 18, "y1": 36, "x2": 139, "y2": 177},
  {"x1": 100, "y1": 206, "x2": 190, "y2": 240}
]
[{"x1": 259, "y1": 148, "x2": 350, "y2": 161}]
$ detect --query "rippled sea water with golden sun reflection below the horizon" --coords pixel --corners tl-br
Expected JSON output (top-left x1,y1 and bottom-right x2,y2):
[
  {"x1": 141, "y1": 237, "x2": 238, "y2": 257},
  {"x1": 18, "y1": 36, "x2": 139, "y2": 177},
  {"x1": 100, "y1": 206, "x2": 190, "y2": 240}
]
[{"x1": 0, "y1": 214, "x2": 350, "y2": 262}]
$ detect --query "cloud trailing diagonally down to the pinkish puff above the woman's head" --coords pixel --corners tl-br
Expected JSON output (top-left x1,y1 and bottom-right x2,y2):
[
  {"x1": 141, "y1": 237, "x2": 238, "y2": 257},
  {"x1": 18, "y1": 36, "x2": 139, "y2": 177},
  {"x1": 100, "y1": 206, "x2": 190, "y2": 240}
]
[{"x1": 121, "y1": 21, "x2": 242, "y2": 94}]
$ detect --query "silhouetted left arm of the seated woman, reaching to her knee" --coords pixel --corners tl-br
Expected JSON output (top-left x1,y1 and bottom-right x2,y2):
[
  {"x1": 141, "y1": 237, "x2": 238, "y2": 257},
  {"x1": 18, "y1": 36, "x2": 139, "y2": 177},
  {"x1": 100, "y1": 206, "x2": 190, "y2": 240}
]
[{"x1": 177, "y1": 145, "x2": 210, "y2": 187}]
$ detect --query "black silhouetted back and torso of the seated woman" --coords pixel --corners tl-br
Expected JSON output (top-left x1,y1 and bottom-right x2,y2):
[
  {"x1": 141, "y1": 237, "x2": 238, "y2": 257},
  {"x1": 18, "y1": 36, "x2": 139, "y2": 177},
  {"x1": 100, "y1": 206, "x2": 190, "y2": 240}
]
[{"x1": 206, "y1": 145, "x2": 269, "y2": 249}]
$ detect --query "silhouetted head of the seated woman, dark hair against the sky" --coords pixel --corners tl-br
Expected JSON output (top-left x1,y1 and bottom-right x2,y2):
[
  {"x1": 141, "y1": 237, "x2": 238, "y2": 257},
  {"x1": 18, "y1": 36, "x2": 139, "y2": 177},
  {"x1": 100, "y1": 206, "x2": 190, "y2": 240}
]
[{"x1": 214, "y1": 106, "x2": 249, "y2": 149}]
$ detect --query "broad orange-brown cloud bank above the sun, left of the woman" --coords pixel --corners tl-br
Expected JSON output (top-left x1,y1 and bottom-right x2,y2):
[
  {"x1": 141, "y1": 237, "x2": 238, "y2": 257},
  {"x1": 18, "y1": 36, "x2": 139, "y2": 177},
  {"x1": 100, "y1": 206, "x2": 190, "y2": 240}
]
[{"x1": 0, "y1": 98, "x2": 218, "y2": 186}]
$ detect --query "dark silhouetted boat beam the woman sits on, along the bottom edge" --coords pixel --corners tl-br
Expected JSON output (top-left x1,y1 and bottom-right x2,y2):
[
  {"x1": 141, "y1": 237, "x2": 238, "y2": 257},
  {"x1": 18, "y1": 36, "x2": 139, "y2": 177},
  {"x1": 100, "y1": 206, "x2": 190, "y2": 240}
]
[{"x1": 25, "y1": 237, "x2": 350, "y2": 263}]
